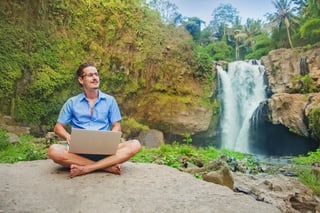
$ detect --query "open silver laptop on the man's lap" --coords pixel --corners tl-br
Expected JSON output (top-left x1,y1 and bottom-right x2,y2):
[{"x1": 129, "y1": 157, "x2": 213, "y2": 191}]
[{"x1": 69, "y1": 128, "x2": 122, "y2": 155}]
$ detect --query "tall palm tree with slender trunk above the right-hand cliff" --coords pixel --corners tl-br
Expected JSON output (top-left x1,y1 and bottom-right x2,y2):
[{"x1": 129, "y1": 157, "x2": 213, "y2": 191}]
[{"x1": 267, "y1": 0, "x2": 298, "y2": 48}]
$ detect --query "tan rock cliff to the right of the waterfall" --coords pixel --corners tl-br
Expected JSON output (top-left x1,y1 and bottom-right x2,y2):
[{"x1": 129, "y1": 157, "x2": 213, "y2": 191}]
[{"x1": 261, "y1": 48, "x2": 320, "y2": 139}]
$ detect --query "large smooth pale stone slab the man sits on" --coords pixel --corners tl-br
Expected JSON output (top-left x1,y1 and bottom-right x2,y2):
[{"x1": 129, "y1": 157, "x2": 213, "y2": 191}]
[{"x1": 0, "y1": 160, "x2": 280, "y2": 213}]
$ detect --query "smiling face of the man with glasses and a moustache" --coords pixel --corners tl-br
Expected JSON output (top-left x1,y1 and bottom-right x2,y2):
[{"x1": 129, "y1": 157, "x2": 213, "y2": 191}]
[{"x1": 78, "y1": 67, "x2": 100, "y2": 89}]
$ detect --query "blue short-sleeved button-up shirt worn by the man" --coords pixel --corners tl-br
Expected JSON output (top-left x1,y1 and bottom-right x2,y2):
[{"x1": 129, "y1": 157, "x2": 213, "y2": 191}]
[{"x1": 57, "y1": 90, "x2": 121, "y2": 130}]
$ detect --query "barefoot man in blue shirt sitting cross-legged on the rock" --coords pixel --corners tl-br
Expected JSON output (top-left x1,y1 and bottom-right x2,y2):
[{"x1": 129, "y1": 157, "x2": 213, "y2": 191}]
[{"x1": 48, "y1": 63, "x2": 141, "y2": 177}]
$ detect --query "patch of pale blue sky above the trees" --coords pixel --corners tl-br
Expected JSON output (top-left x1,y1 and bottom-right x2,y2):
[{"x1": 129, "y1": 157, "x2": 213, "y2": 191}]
[{"x1": 169, "y1": 0, "x2": 275, "y2": 25}]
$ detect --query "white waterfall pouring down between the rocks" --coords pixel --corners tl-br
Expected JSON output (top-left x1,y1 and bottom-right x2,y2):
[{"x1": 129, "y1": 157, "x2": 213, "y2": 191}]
[{"x1": 217, "y1": 61, "x2": 266, "y2": 153}]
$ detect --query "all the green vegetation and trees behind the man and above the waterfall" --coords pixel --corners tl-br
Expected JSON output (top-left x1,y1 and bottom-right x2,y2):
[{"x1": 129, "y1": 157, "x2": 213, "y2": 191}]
[{"x1": 0, "y1": 0, "x2": 320, "y2": 132}]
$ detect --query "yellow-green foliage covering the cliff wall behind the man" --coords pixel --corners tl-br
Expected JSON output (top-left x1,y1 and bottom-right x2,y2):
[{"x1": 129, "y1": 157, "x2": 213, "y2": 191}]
[{"x1": 0, "y1": 0, "x2": 212, "y2": 128}]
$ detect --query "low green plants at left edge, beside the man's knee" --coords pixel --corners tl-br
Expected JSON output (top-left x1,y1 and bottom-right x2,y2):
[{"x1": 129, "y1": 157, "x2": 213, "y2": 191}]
[{"x1": 0, "y1": 131, "x2": 47, "y2": 163}]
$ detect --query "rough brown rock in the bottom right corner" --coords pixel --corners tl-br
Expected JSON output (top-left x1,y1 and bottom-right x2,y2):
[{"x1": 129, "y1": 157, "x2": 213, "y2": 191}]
[{"x1": 234, "y1": 173, "x2": 320, "y2": 213}]
